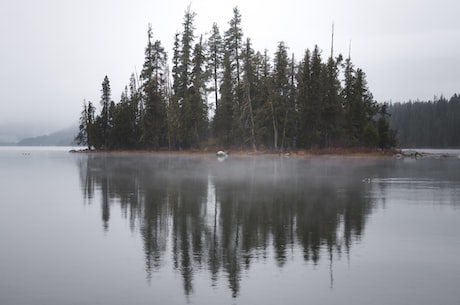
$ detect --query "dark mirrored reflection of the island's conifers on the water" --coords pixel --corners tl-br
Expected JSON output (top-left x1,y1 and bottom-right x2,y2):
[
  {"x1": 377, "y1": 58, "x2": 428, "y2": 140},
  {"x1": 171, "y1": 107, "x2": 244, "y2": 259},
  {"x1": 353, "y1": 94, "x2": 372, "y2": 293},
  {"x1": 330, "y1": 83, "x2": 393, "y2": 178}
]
[{"x1": 79, "y1": 155, "x2": 375, "y2": 297}]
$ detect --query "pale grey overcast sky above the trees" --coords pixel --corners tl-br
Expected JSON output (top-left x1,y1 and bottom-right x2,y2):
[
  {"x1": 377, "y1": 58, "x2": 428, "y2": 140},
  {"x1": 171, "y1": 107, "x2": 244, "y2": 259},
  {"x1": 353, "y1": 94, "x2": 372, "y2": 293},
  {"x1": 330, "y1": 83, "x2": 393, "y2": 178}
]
[{"x1": 0, "y1": 0, "x2": 460, "y2": 132}]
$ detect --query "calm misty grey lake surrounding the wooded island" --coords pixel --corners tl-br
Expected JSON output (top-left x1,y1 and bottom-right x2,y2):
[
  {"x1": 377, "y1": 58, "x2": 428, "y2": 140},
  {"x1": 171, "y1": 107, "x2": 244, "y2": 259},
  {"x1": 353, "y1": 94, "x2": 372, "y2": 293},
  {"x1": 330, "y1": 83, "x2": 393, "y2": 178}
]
[{"x1": 0, "y1": 147, "x2": 460, "y2": 305}]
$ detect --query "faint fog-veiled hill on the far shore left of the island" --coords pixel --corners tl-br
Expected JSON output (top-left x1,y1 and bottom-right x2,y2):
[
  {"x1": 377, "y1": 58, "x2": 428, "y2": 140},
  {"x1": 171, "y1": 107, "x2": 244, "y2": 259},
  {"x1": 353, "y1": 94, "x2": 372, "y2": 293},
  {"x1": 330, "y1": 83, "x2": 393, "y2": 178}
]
[{"x1": 16, "y1": 126, "x2": 78, "y2": 146}]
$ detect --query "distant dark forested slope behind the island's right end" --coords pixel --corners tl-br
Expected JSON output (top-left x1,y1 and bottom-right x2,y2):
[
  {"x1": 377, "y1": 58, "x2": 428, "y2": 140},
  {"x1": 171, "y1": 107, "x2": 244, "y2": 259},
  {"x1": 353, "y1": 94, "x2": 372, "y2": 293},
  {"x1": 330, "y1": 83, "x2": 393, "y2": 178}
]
[{"x1": 388, "y1": 94, "x2": 460, "y2": 148}]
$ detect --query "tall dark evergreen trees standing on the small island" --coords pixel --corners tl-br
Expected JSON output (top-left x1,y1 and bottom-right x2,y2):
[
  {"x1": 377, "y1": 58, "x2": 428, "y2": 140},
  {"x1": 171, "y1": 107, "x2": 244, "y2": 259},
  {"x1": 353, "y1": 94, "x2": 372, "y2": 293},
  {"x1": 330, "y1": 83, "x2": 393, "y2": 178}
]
[{"x1": 76, "y1": 7, "x2": 396, "y2": 151}]
